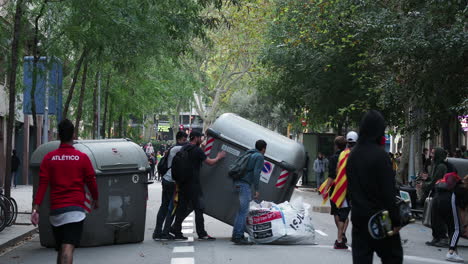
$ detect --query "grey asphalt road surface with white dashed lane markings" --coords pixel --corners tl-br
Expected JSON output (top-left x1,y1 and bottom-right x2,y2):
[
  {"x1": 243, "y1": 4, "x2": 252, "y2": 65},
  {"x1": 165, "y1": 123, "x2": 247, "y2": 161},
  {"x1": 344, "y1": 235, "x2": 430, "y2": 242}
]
[{"x1": 0, "y1": 184, "x2": 468, "y2": 264}]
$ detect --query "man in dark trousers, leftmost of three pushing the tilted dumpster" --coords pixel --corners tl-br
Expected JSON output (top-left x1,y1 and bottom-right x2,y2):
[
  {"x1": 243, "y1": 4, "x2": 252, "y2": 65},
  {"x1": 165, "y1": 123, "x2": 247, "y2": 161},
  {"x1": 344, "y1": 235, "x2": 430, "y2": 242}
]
[{"x1": 153, "y1": 131, "x2": 188, "y2": 240}]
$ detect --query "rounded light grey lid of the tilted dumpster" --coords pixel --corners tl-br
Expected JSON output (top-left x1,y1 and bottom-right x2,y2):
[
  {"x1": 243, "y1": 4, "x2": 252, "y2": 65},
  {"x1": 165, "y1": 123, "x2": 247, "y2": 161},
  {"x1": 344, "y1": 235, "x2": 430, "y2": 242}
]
[{"x1": 210, "y1": 113, "x2": 305, "y2": 170}]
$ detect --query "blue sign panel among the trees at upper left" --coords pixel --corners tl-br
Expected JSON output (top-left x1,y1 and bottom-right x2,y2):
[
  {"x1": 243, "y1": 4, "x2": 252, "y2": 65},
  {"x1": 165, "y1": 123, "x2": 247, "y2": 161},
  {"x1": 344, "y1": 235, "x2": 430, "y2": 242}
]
[{"x1": 23, "y1": 56, "x2": 63, "y2": 120}]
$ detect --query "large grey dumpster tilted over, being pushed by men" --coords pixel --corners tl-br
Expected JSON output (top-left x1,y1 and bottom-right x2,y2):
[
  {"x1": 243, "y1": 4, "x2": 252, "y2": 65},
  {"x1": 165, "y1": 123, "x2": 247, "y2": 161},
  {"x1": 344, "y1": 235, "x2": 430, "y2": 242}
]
[{"x1": 200, "y1": 113, "x2": 305, "y2": 225}]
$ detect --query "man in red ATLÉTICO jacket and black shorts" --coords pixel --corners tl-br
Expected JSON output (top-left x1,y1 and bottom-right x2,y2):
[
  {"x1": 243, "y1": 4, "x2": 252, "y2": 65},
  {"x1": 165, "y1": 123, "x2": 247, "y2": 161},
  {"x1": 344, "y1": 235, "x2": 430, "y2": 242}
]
[{"x1": 31, "y1": 119, "x2": 98, "y2": 264}]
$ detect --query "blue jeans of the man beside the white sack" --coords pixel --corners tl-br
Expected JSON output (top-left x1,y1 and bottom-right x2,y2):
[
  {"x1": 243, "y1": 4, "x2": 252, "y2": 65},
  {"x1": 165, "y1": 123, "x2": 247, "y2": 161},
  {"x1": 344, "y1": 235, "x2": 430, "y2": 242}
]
[{"x1": 232, "y1": 182, "x2": 252, "y2": 238}]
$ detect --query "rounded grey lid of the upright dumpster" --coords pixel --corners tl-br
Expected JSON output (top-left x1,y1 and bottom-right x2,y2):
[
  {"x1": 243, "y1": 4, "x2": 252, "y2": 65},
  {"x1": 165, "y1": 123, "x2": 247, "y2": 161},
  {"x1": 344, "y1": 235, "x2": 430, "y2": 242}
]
[{"x1": 30, "y1": 139, "x2": 148, "y2": 172}]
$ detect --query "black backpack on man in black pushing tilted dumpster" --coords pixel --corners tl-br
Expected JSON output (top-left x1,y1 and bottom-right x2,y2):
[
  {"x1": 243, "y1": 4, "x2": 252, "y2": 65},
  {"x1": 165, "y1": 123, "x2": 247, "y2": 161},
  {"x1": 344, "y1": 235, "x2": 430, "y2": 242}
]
[{"x1": 171, "y1": 145, "x2": 196, "y2": 185}]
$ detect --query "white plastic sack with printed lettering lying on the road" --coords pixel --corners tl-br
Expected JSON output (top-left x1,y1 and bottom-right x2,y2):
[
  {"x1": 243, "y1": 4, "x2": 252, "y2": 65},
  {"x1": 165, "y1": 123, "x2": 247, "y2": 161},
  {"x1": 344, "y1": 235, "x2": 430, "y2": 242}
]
[{"x1": 247, "y1": 198, "x2": 316, "y2": 245}]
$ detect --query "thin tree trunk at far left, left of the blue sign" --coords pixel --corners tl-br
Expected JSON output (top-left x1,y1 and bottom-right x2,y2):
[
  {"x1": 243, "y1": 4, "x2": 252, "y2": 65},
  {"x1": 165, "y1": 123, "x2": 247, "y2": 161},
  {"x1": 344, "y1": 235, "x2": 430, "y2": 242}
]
[{"x1": 4, "y1": 0, "x2": 23, "y2": 197}]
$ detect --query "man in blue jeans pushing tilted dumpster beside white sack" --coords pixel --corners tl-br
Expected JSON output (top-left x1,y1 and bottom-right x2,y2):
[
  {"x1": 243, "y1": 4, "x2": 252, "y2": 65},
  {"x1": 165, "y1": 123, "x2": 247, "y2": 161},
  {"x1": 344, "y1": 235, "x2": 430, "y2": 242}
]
[{"x1": 231, "y1": 140, "x2": 267, "y2": 245}]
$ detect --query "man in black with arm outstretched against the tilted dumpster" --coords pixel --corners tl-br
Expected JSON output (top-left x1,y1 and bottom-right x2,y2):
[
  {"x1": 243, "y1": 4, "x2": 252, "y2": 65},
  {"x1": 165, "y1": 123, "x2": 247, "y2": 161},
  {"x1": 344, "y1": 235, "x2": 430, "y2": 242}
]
[{"x1": 171, "y1": 131, "x2": 226, "y2": 240}]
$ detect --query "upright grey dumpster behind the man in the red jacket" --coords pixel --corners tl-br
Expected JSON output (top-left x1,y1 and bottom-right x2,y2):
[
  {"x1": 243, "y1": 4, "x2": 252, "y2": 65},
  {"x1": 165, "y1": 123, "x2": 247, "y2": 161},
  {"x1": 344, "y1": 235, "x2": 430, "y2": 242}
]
[{"x1": 30, "y1": 139, "x2": 148, "y2": 247}]
